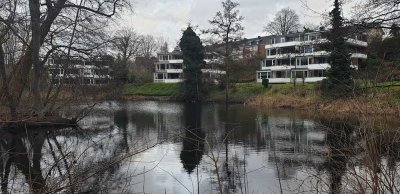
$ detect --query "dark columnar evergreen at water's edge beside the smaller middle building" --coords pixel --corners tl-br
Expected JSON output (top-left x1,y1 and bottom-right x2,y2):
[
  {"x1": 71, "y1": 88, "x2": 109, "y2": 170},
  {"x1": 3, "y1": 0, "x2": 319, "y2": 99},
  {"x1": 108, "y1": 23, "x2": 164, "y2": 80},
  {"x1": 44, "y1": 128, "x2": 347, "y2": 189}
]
[{"x1": 179, "y1": 26, "x2": 204, "y2": 102}]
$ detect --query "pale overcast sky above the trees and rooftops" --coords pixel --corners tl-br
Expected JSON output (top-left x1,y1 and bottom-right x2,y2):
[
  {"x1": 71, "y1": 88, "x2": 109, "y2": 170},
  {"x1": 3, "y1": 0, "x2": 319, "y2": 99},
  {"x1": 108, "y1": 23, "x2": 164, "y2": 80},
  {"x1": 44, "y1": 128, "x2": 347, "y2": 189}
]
[{"x1": 118, "y1": 0, "x2": 356, "y2": 49}]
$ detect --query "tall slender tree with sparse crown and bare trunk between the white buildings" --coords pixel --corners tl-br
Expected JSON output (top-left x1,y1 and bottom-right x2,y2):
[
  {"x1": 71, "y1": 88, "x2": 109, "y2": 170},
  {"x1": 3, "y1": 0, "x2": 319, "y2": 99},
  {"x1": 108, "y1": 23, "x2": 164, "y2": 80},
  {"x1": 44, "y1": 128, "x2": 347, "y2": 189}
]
[{"x1": 205, "y1": 0, "x2": 244, "y2": 105}]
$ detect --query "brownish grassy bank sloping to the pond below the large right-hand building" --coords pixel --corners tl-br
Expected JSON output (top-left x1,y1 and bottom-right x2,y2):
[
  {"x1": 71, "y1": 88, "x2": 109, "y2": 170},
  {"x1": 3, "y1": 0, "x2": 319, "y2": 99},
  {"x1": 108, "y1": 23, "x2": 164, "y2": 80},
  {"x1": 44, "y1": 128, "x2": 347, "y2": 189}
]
[{"x1": 246, "y1": 83, "x2": 400, "y2": 115}]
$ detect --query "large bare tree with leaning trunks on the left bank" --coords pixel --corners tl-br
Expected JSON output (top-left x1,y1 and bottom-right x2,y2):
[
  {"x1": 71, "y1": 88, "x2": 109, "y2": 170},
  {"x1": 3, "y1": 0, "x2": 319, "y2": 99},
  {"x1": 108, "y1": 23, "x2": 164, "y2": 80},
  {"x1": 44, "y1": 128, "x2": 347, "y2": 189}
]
[{"x1": 0, "y1": 0, "x2": 130, "y2": 120}]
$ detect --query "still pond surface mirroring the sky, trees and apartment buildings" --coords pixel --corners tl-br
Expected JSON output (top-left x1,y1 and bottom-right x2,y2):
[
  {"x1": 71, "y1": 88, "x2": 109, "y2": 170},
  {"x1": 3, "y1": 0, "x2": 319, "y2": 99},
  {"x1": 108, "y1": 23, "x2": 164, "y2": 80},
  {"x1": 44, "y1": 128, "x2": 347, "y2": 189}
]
[{"x1": 0, "y1": 102, "x2": 400, "y2": 193}]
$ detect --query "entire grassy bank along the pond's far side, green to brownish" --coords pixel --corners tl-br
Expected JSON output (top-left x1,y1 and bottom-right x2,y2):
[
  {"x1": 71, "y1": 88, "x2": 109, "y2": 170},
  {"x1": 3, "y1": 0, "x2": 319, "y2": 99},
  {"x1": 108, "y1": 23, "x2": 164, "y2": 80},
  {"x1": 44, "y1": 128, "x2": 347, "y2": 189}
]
[{"x1": 123, "y1": 82, "x2": 400, "y2": 115}]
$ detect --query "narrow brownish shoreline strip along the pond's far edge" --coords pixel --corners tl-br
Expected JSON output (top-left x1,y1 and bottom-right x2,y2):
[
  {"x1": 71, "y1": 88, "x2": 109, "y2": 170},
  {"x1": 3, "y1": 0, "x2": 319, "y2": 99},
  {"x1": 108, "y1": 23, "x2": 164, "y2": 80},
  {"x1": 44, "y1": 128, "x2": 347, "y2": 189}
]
[{"x1": 121, "y1": 95, "x2": 400, "y2": 117}]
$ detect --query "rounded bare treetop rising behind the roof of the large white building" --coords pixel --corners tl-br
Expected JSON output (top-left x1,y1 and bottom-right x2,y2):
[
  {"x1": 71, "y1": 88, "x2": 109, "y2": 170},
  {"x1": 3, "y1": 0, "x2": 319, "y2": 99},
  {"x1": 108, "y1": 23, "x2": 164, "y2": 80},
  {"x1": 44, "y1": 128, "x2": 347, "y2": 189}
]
[{"x1": 264, "y1": 8, "x2": 300, "y2": 35}]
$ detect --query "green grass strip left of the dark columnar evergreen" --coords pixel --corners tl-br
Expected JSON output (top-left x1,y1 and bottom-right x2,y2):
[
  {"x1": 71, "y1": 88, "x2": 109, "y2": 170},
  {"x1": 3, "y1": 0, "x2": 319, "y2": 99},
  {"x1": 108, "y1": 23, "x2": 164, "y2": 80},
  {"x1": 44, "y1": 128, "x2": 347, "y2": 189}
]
[{"x1": 124, "y1": 83, "x2": 179, "y2": 96}]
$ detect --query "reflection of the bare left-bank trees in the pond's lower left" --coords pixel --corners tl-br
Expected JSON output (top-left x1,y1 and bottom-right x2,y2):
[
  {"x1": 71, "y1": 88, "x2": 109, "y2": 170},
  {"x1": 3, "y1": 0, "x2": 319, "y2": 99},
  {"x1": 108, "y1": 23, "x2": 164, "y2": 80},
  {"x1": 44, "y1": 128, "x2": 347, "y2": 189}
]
[{"x1": 0, "y1": 120, "x2": 134, "y2": 193}]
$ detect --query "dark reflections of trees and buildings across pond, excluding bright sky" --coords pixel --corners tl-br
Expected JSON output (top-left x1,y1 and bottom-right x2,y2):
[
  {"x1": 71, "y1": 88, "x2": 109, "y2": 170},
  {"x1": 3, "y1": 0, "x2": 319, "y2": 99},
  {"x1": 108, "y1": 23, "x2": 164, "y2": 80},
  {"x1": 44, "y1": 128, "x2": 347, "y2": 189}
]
[{"x1": 5, "y1": 104, "x2": 400, "y2": 193}]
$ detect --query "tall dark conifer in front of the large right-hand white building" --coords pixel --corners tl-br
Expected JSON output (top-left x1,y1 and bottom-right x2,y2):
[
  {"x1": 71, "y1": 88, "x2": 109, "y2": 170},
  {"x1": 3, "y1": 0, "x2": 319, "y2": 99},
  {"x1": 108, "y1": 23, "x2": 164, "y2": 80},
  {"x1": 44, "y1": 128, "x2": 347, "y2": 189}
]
[{"x1": 322, "y1": 0, "x2": 354, "y2": 98}]
